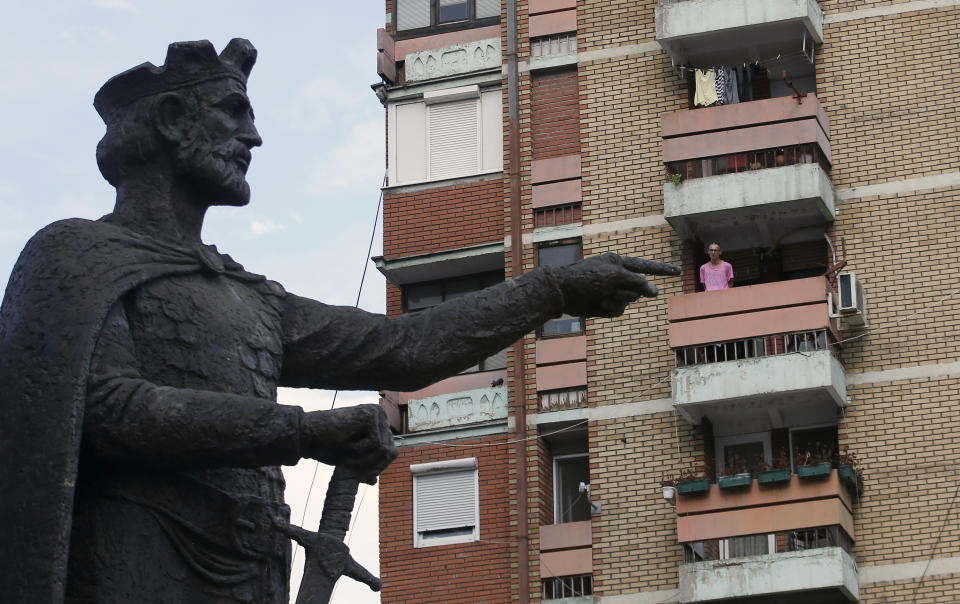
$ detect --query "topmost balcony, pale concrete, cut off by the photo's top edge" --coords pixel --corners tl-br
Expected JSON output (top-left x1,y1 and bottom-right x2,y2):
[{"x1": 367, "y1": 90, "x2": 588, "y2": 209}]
[{"x1": 656, "y1": 0, "x2": 823, "y2": 65}]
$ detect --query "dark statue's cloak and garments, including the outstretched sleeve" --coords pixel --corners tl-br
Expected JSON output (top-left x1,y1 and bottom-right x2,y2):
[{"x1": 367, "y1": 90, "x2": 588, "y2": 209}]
[{"x1": 0, "y1": 216, "x2": 562, "y2": 604}]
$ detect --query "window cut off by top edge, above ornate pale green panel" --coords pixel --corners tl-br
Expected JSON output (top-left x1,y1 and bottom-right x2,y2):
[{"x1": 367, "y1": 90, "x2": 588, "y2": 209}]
[{"x1": 393, "y1": 0, "x2": 500, "y2": 37}]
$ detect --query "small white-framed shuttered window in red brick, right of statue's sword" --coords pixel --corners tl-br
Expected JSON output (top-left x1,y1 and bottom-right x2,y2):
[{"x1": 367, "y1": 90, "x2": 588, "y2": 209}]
[{"x1": 410, "y1": 457, "x2": 480, "y2": 547}]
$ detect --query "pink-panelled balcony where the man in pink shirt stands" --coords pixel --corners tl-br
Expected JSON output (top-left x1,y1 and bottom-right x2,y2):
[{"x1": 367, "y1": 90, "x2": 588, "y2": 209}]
[{"x1": 668, "y1": 277, "x2": 846, "y2": 432}]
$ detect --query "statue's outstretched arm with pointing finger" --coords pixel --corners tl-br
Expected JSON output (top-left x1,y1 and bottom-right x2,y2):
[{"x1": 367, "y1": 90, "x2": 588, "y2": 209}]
[{"x1": 281, "y1": 253, "x2": 680, "y2": 391}]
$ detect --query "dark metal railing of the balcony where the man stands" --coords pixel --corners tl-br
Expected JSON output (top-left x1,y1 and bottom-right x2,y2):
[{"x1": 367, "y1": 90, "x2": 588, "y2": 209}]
[{"x1": 675, "y1": 329, "x2": 834, "y2": 367}]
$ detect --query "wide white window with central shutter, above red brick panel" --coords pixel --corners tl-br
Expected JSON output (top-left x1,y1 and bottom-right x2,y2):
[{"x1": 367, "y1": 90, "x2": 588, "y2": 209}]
[{"x1": 387, "y1": 86, "x2": 503, "y2": 185}]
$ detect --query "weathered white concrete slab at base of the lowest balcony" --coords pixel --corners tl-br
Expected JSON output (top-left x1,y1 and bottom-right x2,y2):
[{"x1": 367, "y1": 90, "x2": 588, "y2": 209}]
[{"x1": 680, "y1": 547, "x2": 860, "y2": 604}]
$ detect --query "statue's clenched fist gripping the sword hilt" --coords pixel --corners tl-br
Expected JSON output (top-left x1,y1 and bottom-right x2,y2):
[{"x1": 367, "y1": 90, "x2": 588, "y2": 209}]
[{"x1": 300, "y1": 405, "x2": 397, "y2": 484}]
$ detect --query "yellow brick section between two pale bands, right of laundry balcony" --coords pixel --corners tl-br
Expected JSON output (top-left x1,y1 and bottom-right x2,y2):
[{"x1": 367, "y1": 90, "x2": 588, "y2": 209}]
[{"x1": 817, "y1": 6, "x2": 960, "y2": 188}]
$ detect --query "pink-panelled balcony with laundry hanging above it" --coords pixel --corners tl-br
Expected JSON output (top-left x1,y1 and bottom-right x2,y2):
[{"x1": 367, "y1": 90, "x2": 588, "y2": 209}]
[{"x1": 661, "y1": 94, "x2": 836, "y2": 247}]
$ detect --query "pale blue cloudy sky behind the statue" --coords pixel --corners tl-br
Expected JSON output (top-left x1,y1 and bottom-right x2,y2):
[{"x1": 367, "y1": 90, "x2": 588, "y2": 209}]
[{"x1": 0, "y1": 0, "x2": 385, "y2": 604}]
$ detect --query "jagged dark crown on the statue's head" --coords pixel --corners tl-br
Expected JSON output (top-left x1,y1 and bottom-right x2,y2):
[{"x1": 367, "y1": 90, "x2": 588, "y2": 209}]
[{"x1": 93, "y1": 38, "x2": 257, "y2": 123}]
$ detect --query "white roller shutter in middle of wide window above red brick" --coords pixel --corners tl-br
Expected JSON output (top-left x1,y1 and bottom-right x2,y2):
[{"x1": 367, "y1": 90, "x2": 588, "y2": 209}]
[{"x1": 428, "y1": 99, "x2": 480, "y2": 180}]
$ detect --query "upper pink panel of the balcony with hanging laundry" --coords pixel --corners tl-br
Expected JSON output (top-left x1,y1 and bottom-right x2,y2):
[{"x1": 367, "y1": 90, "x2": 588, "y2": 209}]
[{"x1": 660, "y1": 94, "x2": 830, "y2": 138}]
